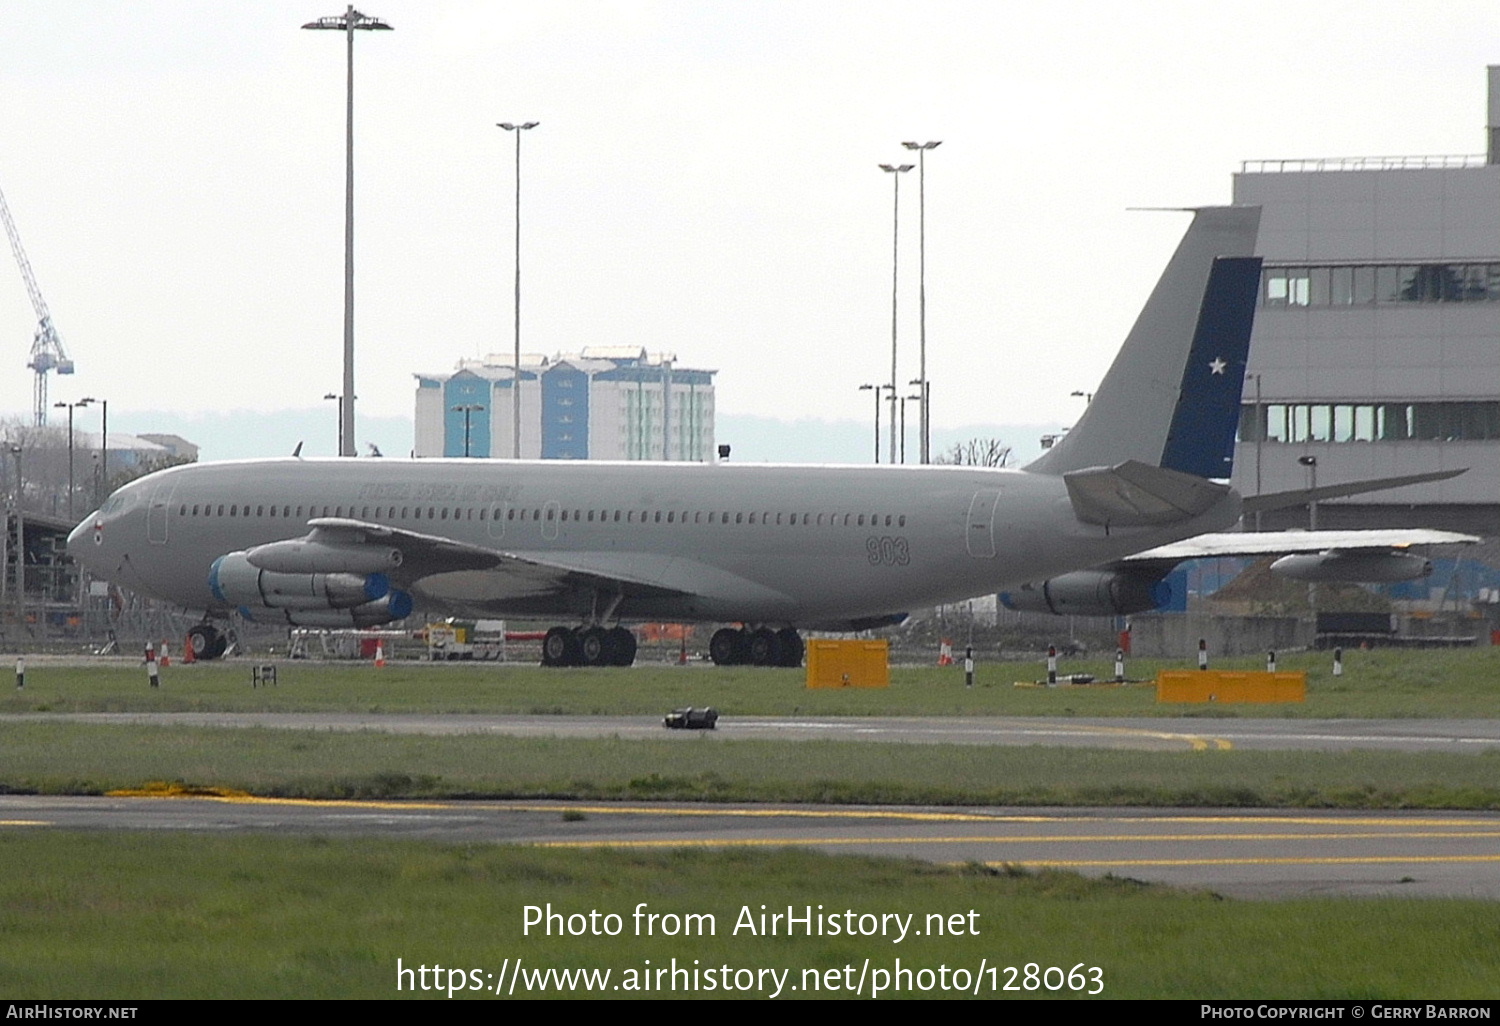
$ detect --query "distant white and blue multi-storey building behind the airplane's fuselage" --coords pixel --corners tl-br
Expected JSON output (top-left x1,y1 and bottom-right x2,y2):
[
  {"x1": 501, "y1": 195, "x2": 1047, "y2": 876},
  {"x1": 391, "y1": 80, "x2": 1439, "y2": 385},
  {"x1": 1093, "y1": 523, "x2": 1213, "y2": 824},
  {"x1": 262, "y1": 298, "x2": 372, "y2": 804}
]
[{"x1": 414, "y1": 347, "x2": 716, "y2": 462}]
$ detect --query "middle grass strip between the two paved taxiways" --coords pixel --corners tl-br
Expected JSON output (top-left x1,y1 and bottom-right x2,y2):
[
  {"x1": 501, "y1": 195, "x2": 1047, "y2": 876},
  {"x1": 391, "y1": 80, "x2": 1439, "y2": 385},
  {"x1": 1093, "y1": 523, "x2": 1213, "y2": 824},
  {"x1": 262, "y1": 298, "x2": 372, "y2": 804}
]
[{"x1": 0, "y1": 722, "x2": 1500, "y2": 809}]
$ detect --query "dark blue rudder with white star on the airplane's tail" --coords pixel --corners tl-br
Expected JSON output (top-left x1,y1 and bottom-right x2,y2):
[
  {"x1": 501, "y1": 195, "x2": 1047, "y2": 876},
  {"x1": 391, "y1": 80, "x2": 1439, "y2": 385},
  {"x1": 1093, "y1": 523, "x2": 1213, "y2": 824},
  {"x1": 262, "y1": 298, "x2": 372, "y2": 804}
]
[{"x1": 1161, "y1": 257, "x2": 1260, "y2": 479}]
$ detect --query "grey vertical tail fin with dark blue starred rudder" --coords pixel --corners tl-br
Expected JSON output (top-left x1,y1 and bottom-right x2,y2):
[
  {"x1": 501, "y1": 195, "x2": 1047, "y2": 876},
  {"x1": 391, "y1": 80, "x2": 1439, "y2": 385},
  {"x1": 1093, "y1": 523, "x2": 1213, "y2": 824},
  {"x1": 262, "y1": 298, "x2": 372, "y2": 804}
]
[{"x1": 1026, "y1": 207, "x2": 1260, "y2": 479}]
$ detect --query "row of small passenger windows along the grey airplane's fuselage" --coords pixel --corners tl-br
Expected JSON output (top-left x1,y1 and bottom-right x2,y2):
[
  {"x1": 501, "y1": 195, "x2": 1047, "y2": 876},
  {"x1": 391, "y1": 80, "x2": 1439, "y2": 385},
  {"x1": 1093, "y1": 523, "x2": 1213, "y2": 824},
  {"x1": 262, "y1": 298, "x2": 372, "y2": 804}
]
[{"x1": 177, "y1": 503, "x2": 906, "y2": 527}]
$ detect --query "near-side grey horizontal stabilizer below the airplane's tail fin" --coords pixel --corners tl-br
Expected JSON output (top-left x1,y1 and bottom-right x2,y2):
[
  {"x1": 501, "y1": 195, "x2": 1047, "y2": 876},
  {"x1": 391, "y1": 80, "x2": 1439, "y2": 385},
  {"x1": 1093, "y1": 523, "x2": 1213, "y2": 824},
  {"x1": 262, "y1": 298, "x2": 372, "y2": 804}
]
[{"x1": 1062, "y1": 459, "x2": 1229, "y2": 527}]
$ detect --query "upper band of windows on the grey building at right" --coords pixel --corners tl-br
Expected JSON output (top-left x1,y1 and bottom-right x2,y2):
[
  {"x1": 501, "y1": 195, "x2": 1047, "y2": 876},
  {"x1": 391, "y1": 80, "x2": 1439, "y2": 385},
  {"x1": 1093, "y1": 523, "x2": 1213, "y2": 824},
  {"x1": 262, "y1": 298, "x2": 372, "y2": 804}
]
[{"x1": 1260, "y1": 264, "x2": 1500, "y2": 308}]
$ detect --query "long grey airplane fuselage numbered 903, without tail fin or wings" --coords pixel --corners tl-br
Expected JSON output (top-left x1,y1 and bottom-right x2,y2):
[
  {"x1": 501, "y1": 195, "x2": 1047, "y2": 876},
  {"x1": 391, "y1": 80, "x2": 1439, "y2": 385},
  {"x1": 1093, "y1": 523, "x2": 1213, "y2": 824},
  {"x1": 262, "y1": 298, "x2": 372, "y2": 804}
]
[{"x1": 69, "y1": 458, "x2": 1239, "y2": 627}]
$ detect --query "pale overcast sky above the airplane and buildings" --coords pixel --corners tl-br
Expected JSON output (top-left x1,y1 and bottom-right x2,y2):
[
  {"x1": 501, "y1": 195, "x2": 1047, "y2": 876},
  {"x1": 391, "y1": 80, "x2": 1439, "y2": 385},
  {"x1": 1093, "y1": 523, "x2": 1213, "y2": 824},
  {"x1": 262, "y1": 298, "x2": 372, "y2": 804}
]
[{"x1": 0, "y1": 0, "x2": 1500, "y2": 456}]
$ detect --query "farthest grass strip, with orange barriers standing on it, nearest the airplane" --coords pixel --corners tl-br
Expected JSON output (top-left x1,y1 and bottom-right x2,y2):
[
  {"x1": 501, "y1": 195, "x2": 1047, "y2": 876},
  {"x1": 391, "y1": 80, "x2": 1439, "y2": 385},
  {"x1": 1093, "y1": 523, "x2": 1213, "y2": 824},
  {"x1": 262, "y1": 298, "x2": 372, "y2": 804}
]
[{"x1": 0, "y1": 648, "x2": 1500, "y2": 719}]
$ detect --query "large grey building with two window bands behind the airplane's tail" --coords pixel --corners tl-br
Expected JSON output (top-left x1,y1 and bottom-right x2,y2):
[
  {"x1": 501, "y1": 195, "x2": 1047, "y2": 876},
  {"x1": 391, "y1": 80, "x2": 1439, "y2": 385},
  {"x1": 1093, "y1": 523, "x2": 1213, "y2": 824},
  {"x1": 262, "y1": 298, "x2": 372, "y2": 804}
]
[{"x1": 1235, "y1": 68, "x2": 1500, "y2": 537}]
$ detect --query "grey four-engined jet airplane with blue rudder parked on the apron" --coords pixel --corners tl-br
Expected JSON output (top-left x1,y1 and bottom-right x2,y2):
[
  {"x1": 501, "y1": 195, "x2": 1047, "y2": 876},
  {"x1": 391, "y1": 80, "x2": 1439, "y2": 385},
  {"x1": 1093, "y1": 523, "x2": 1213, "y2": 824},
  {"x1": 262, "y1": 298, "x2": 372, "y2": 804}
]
[{"x1": 68, "y1": 207, "x2": 1470, "y2": 666}]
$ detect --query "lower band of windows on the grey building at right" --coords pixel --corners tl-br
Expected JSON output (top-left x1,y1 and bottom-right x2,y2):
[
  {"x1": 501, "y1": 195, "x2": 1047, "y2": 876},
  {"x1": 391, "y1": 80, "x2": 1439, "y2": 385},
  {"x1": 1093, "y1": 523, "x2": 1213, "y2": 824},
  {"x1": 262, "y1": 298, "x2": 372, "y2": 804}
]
[{"x1": 1239, "y1": 402, "x2": 1500, "y2": 443}]
